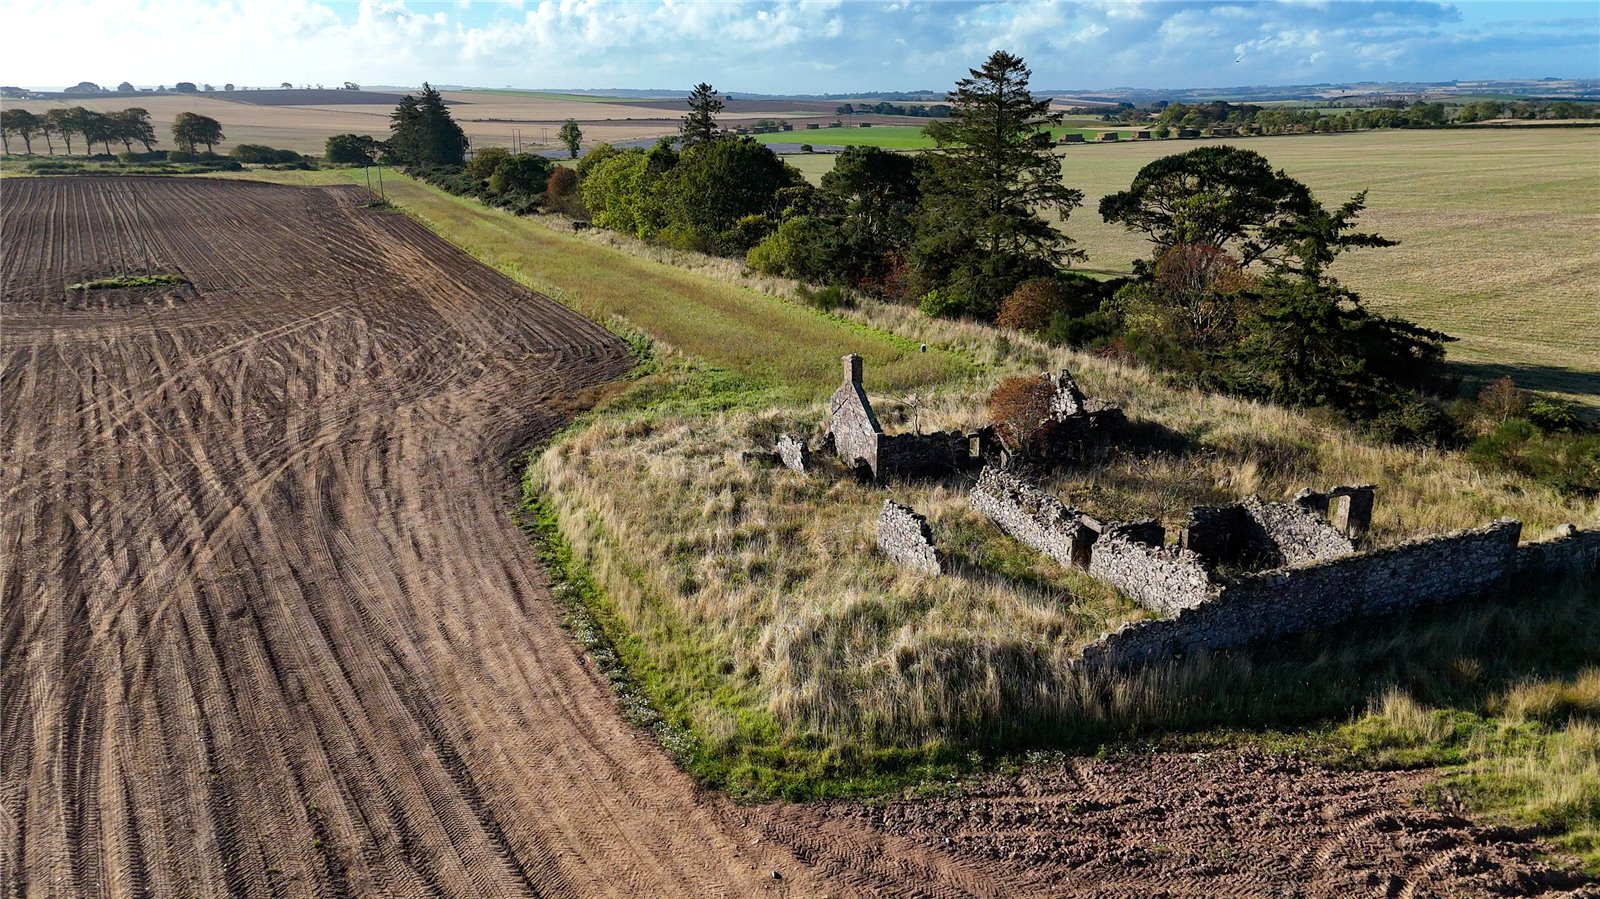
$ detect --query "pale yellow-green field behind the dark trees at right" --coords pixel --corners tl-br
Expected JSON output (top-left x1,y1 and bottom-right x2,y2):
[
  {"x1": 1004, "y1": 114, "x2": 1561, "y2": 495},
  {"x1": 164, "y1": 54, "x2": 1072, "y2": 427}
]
[{"x1": 786, "y1": 128, "x2": 1600, "y2": 410}]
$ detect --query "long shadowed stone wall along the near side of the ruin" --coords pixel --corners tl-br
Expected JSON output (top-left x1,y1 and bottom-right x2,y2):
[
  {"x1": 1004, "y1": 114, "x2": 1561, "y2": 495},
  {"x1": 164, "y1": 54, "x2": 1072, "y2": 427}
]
[{"x1": 1082, "y1": 518, "x2": 1522, "y2": 667}]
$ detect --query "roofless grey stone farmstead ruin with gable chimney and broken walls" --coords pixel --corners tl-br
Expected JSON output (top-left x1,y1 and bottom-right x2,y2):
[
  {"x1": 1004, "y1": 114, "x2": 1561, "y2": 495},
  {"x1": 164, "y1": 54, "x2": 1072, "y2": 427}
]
[{"x1": 768, "y1": 355, "x2": 1600, "y2": 667}]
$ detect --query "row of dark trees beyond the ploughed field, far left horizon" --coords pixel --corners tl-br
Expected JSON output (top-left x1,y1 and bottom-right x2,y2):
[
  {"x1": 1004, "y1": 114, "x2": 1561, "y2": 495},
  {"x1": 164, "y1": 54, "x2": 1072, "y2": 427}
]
[{"x1": 0, "y1": 106, "x2": 224, "y2": 155}]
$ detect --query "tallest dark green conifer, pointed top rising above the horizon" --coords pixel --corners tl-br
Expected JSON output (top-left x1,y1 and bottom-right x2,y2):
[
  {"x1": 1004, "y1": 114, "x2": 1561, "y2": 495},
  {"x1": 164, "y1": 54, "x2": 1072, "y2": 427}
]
[{"x1": 914, "y1": 51, "x2": 1083, "y2": 318}]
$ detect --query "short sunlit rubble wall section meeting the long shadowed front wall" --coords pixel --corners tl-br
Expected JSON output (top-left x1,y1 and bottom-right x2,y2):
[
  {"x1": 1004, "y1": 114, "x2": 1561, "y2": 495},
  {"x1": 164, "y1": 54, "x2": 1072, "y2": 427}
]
[{"x1": 1090, "y1": 523, "x2": 1219, "y2": 614}]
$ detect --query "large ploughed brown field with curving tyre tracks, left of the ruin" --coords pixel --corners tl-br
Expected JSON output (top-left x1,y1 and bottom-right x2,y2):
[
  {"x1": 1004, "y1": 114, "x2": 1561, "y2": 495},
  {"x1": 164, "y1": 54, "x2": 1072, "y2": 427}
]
[{"x1": 0, "y1": 179, "x2": 1587, "y2": 897}]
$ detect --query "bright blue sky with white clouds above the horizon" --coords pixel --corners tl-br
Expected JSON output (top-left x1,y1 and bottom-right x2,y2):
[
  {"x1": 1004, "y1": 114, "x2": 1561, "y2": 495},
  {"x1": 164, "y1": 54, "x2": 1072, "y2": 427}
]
[{"x1": 0, "y1": 0, "x2": 1600, "y2": 94}]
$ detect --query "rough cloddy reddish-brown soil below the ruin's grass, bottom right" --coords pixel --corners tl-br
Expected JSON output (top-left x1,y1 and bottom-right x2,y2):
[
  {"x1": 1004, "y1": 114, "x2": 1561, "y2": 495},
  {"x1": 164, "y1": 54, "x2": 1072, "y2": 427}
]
[{"x1": 829, "y1": 750, "x2": 1600, "y2": 899}]
